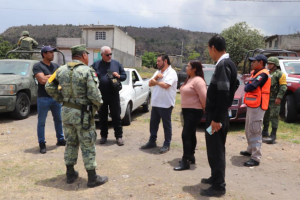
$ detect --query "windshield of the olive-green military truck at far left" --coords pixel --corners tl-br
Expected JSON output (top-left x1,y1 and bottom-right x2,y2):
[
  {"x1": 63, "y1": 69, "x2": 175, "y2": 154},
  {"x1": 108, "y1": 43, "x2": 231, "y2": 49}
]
[{"x1": 0, "y1": 61, "x2": 30, "y2": 76}]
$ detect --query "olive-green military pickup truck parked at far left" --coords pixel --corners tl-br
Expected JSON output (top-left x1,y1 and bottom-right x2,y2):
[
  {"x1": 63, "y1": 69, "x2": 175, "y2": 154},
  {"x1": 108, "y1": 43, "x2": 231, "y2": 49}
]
[{"x1": 0, "y1": 50, "x2": 64, "y2": 119}]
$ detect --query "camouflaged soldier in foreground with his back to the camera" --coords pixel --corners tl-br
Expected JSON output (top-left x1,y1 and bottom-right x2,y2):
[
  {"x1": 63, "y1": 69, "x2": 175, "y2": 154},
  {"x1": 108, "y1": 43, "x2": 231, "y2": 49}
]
[{"x1": 45, "y1": 45, "x2": 108, "y2": 187}]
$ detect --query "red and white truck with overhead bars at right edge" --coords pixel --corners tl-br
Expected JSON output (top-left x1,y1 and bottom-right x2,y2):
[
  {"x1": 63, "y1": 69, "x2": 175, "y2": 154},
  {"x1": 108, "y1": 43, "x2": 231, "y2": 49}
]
[{"x1": 242, "y1": 49, "x2": 300, "y2": 122}]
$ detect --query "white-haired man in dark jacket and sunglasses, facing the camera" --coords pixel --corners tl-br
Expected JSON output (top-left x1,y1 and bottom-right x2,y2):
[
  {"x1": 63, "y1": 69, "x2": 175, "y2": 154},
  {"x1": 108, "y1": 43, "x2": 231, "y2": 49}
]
[{"x1": 92, "y1": 46, "x2": 127, "y2": 146}]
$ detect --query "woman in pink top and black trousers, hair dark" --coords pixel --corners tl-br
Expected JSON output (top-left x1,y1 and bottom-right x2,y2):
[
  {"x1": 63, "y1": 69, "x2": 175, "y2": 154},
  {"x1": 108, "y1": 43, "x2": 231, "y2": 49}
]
[{"x1": 174, "y1": 60, "x2": 206, "y2": 171}]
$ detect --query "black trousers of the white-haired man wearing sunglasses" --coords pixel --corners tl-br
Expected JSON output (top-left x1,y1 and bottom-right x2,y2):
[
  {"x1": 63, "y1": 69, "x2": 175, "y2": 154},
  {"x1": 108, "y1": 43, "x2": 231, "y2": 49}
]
[{"x1": 99, "y1": 93, "x2": 123, "y2": 138}]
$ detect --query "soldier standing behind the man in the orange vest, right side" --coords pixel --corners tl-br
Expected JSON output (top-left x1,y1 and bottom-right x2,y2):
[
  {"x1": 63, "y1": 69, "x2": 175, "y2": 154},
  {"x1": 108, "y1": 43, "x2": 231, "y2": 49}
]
[{"x1": 262, "y1": 57, "x2": 287, "y2": 144}]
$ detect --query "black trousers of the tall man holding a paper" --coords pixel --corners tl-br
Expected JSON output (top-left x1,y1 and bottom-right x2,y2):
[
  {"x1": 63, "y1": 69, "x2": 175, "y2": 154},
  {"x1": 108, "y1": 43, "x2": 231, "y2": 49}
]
[{"x1": 205, "y1": 112, "x2": 229, "y2": 190}]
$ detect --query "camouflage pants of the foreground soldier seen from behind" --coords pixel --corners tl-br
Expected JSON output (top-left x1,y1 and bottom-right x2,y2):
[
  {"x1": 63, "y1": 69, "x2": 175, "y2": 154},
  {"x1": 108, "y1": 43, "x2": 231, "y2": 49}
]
[{"x1": 63, "y1": 123, "x2": 97, "y2": 170}]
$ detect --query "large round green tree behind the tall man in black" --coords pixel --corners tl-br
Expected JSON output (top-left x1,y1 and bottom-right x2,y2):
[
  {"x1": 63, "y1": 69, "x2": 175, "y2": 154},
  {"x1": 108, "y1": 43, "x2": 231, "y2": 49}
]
[{"x1": 221, "y1": 22, "x2": 265, "y2": 66}]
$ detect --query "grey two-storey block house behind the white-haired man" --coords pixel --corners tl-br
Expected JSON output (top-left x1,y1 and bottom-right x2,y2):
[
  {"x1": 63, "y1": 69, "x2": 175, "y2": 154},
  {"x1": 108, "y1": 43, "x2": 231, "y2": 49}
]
[{"x1": 56, "y1": 25, "x2": 142, "y2": 67}]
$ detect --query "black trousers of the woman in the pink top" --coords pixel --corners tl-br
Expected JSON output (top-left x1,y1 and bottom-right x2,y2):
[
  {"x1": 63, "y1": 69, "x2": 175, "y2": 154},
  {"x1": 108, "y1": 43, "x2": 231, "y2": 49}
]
[{"x1": 181, "y1": 108, "x2": 203, "y2": 159}]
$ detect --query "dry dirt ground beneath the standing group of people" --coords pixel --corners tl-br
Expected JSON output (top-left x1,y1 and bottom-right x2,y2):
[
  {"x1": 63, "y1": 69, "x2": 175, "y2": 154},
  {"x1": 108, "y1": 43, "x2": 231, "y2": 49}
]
[{"x1": 0, "y1": 101, "x2": 300, "y2": 200}]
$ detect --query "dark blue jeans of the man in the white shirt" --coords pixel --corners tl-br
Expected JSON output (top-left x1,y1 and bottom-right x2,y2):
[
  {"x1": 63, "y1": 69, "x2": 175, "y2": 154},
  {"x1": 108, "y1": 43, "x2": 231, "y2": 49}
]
[{"x1": 149, "y1": 106, "x2": 173, "y2": 147}]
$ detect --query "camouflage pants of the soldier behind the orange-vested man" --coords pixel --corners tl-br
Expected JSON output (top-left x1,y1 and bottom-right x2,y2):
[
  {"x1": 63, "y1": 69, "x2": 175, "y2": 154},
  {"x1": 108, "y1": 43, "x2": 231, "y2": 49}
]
[{"x1": 264, "y1": 100, "x2": 280, "y2": 130}]
